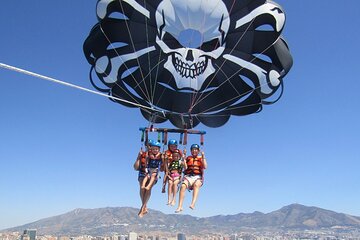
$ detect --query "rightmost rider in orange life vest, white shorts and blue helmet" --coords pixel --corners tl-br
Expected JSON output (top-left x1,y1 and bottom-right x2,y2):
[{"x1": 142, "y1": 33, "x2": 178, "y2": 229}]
[{"x1": 175, "y1": 144, "x2": 207, "y2": 213}]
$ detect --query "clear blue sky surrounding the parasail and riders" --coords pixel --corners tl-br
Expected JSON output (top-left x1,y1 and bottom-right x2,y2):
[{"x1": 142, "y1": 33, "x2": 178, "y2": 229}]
[{"x1": 0, "y1": 0, "x2": 360, "y2": 229}]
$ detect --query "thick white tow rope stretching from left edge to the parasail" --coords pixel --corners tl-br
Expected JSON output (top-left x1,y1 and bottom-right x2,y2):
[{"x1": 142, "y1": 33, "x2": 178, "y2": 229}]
[{"x1": 0, "y1": 63, "x2": 160, "y2": 112}]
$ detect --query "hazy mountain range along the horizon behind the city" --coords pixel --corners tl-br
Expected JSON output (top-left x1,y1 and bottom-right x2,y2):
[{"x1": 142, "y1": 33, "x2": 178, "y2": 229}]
[{"x1": 6, "y1": 204, "x2": 360, "y2": 236}]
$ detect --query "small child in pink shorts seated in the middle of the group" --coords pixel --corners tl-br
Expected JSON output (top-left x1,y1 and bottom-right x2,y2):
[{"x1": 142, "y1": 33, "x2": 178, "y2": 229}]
[{"x1": 167, "y1": 149, "x2": 184, "y2": 206}]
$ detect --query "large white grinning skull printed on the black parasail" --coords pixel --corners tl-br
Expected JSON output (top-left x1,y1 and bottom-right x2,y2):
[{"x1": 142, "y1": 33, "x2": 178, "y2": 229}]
[{"x1": 156, "y1": 0, "x2": 230, "y2": 91}]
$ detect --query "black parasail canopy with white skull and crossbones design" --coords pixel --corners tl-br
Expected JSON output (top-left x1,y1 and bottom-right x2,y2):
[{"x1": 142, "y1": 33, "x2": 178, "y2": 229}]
[{"x1": 84, "y1": 0, "x2": 293, "y2": 129}]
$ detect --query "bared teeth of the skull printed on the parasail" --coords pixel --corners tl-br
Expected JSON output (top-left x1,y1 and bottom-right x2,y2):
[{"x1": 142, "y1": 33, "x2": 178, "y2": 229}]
[{"x1": 173, "y1": 56, "x2": 207, "y2": 78}]
